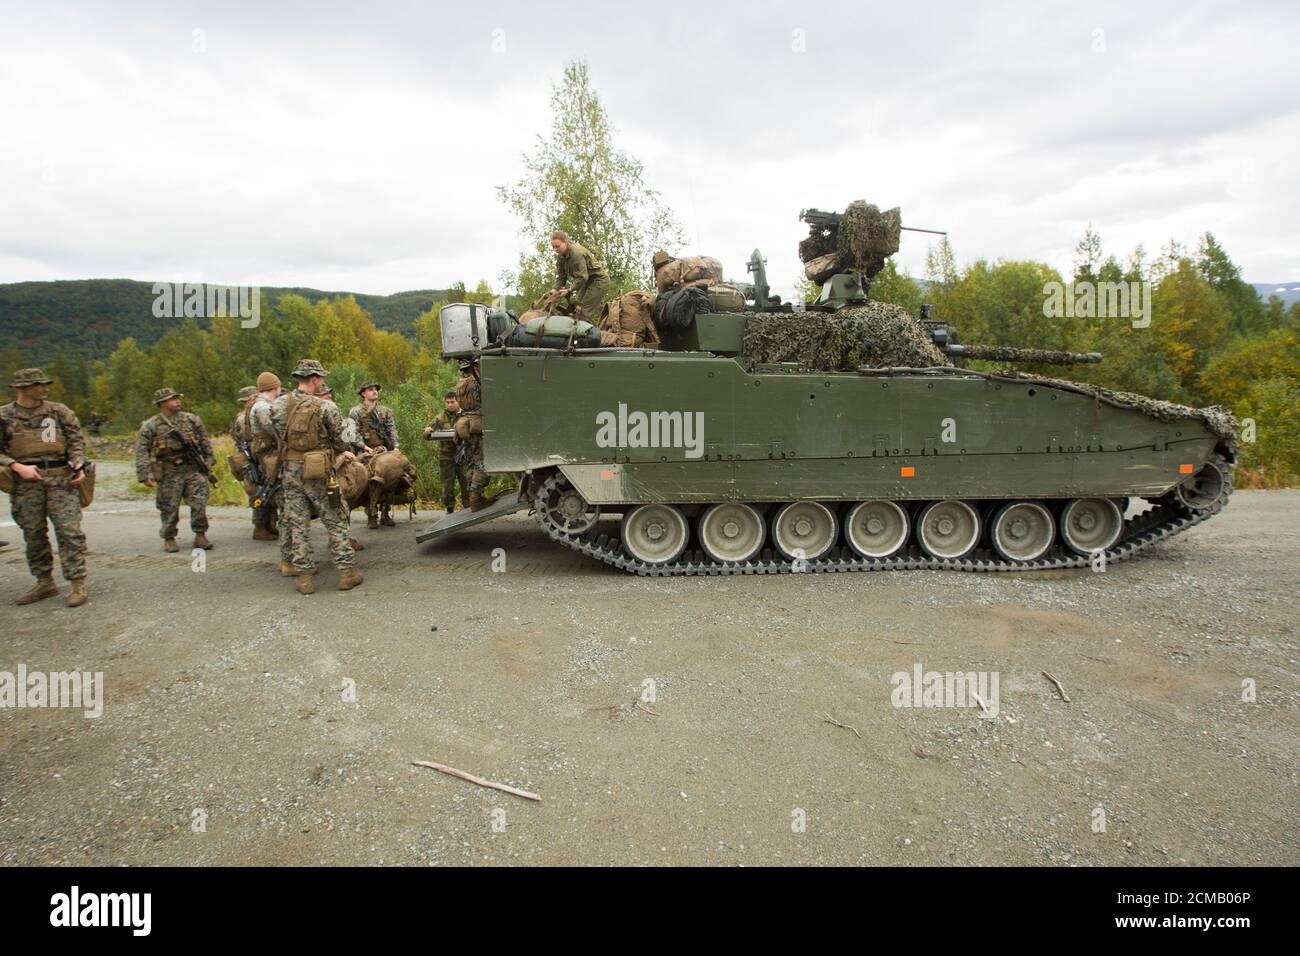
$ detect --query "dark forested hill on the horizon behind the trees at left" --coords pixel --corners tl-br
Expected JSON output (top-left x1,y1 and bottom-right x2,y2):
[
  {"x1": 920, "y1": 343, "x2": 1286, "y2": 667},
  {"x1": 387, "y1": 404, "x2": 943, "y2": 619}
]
[{"x1": 0, "y1": 278, "x2": 462, "y2": 363}]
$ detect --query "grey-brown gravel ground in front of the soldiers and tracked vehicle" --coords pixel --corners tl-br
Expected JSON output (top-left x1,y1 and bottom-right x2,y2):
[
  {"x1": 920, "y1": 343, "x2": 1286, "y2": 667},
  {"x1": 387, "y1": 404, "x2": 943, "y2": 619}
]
[{"x1": 0, "y1": 478, "x2": 1300, "y2": 865}]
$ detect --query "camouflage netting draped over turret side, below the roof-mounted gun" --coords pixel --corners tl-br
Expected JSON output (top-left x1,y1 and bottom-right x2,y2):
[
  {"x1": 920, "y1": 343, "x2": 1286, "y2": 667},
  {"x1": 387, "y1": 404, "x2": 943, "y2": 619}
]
[{"x1": 744, "y1": 302, "x2": 952, "y2": 372}]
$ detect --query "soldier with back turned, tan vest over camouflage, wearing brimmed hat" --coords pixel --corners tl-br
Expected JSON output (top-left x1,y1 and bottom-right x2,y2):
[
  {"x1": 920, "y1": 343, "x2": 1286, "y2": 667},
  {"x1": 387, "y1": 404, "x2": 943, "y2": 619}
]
[{"x1": 270, "y1": 359, "x2": 361, "y2": 594}]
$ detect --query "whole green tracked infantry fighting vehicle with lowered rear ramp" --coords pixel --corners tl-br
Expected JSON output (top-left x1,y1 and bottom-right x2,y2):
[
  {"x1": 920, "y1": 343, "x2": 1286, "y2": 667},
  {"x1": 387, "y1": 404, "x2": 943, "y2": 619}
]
[{"x1": 417, "y1": 207, "x2": 1235, "y2": 575}]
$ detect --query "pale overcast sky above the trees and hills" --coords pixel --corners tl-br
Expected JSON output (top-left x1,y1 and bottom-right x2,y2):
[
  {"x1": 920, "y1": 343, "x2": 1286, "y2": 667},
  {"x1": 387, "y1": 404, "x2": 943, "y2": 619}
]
[{"x1": 0, "y1": 0, "x2": 1300, "y2": 299}]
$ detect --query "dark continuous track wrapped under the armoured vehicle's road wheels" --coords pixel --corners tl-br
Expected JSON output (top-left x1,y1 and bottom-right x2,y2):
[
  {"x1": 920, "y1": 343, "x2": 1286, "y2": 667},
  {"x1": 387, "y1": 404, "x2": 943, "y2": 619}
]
[{"x1": 536, "y1": 476, "x2": 1232, "y2": 578}]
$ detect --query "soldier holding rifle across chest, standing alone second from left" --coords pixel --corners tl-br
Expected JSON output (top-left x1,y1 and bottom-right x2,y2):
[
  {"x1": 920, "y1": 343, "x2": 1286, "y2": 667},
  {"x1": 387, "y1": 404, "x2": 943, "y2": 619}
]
[{"x1": 135, "y1": 389, "x2": 216, "y2": 551}]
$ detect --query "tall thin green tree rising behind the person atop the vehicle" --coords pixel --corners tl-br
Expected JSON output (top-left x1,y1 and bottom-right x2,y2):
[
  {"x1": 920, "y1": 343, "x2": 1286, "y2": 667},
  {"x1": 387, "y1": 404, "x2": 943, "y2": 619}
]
[{"x1": 498, "y1": 61, "x2": 683, "y2": 302}]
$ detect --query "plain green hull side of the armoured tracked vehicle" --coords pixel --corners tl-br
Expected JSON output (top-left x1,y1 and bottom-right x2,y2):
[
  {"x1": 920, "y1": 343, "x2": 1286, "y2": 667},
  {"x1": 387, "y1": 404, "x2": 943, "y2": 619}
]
[{"x1": 481, "y1": 350, "x2": 1221, "y2": 506}]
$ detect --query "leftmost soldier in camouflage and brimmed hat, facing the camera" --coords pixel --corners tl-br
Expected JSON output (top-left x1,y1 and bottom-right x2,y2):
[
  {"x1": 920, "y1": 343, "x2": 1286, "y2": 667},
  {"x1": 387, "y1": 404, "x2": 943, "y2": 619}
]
[{"x1": 0, "y1": 368, "x2": 87, "y2": 607}]
